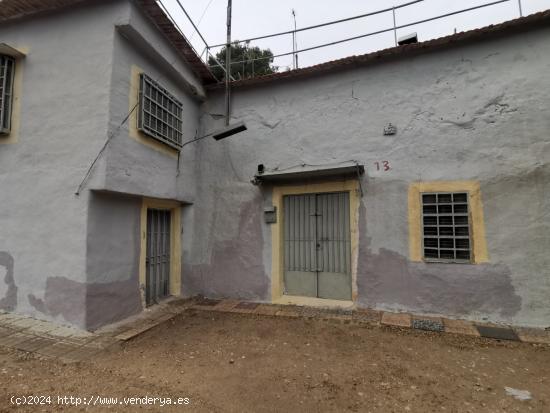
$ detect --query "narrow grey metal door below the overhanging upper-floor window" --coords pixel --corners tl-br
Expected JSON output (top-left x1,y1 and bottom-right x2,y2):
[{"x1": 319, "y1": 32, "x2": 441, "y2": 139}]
[{"x1": 145, "y1": 209, "x2": 171, "y2": 305}]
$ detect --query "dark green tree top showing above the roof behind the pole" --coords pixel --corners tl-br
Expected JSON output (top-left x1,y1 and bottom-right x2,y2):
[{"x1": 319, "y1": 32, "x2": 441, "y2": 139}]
[{"x1": 208, "y1": 43, "x2": 278, "y2": 80}]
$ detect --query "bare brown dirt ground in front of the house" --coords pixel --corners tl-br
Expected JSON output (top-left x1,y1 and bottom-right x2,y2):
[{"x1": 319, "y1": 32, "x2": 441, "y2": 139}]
[{"x1": 0, "y1": 310, "x2": 550, "y2": 412}]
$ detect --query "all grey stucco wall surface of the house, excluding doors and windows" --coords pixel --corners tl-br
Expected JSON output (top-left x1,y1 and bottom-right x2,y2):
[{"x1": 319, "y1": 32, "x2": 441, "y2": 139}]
[{"x1": 0, "y1": 0, "x2": 550, "y2": 328}]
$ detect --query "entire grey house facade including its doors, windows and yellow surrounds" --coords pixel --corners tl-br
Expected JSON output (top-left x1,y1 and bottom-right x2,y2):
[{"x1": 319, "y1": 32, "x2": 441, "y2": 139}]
[{"x1": 0, "y1": 0, "x2": 550, "y2": 329}]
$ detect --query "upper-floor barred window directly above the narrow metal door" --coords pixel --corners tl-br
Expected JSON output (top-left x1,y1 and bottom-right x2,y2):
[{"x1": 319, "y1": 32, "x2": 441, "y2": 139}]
[{"x1": 138, "y1": 73, "x2": 183, "y2": 150}]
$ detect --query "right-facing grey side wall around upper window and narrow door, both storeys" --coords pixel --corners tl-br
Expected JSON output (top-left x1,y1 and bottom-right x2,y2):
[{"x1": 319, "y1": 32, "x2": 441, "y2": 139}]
[{"x1": 82, "y1": 3, "x2": 204, "y2": 329}]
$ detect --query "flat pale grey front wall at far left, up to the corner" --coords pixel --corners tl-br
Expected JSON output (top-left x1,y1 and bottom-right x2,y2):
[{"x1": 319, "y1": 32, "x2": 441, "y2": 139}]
[{"x1": 0, "y1": 2, "x2": 128, "y2": 326}]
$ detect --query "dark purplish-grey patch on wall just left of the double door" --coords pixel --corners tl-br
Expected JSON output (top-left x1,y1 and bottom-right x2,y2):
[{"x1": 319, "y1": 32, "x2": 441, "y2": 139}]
[{"x1": 188, "y1": 196, "x2": 270, "y2": 300}]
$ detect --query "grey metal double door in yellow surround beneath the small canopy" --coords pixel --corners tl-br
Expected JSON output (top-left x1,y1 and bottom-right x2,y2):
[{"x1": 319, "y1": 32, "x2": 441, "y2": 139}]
[{"x1": 283, "y1": 192, "x2": 351, "y2": 300}]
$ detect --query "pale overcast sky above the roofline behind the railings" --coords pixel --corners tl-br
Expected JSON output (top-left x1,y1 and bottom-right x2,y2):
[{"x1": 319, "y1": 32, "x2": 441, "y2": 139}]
[{"x1": 162, "y1": 0, "x2": 550, "y2": 70}]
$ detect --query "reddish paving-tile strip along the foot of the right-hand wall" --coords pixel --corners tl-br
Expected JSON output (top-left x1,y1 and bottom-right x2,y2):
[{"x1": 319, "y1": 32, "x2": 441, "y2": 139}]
[{"x1": 188, "y1": 299, "x2": 550, "y2": 345}]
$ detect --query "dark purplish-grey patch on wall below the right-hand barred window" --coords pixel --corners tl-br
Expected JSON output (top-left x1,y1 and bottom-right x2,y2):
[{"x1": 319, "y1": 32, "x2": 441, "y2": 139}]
[{"x1": 357, "y1": 203, "x2": 521, "y2": 318}]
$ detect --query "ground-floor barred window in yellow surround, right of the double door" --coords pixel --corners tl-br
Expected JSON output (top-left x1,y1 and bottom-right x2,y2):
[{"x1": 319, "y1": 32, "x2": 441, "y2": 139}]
[{"x1": 422, "y1": 192, "x2": 471, "y2": 262}]
